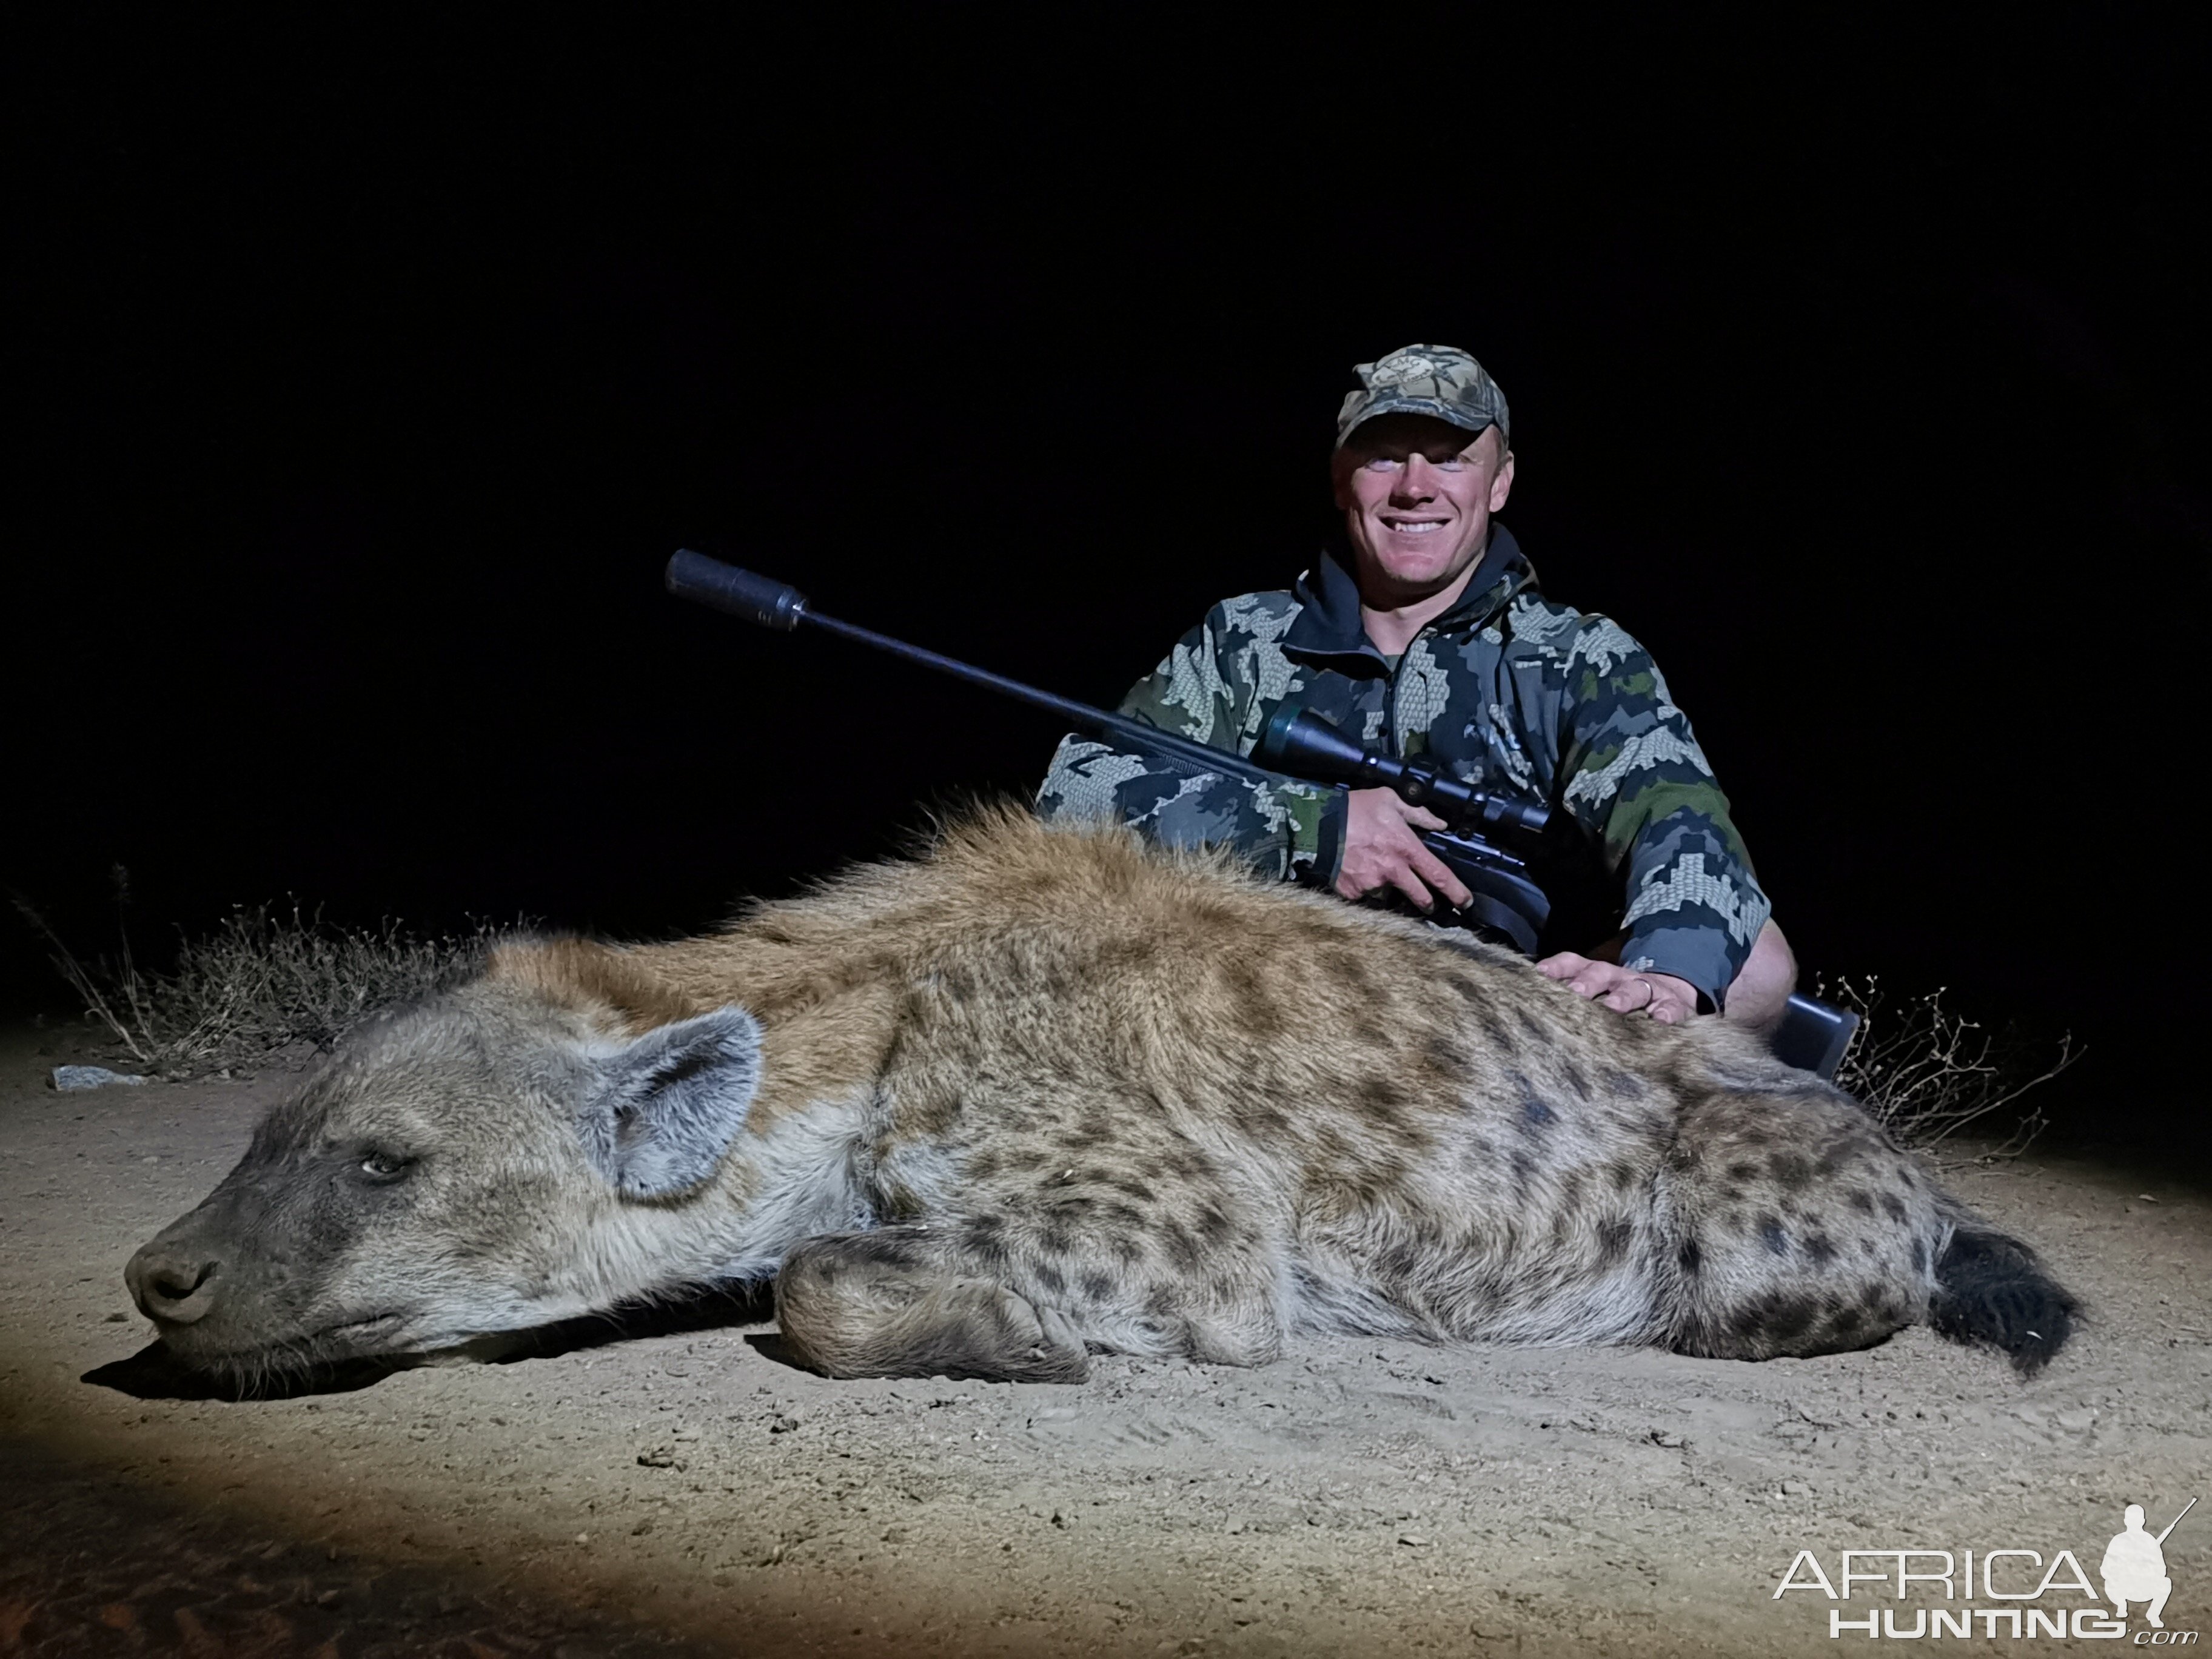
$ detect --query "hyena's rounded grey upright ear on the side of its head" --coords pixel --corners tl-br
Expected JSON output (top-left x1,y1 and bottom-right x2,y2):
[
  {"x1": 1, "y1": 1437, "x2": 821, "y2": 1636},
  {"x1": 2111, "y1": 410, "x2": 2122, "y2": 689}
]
[{"x1": 580, "y1": 1007, "x2": 761, "y2": 1199}]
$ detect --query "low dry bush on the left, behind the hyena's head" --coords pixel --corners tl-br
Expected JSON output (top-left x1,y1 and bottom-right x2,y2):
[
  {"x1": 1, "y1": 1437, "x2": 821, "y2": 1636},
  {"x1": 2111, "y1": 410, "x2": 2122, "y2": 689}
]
[{"x1": 16, "y1": 865, "x2": 504, "y2": 1075}]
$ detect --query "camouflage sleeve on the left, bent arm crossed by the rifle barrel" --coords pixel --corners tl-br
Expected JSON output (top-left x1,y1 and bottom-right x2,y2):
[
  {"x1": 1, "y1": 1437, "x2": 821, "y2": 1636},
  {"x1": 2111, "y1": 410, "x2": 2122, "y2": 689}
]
[{"x1": 1037, "y1": 606, "x2": 1345, "y2": 885}]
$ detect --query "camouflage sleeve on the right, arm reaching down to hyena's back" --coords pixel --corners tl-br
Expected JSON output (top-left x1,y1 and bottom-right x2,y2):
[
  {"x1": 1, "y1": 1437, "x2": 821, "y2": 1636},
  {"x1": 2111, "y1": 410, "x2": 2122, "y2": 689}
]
[{"x1": 1560, "y1": 617, "x2": 1772, "y2": 1008}]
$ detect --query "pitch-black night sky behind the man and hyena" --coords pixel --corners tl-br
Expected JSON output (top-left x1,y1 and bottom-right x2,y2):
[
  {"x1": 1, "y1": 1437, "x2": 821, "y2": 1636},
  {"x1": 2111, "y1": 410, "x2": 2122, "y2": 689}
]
[{"x1": 0, "y1": 20, "x2": 2212, "y2": 1141}]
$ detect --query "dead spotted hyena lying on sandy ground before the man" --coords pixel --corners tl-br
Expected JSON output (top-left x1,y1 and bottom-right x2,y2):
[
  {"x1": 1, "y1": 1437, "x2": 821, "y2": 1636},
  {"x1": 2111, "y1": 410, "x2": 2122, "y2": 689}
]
[{"x1": 129, "y1": 812, "x2": 2073, "y2": 1382}]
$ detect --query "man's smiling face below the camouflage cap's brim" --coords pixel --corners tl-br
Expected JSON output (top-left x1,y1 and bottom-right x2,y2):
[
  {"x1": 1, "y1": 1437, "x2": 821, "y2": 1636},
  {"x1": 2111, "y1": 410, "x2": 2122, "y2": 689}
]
[{"x1": 1336, "y1": 414, "x2": 1513, "y2": 608}]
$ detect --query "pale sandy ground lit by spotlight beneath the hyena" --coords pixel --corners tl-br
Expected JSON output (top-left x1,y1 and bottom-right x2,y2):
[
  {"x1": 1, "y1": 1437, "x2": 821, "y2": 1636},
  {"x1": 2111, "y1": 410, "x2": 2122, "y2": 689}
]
[{"x1": 0, "y1": 1027, "x2": 2212, "y2": 1659}]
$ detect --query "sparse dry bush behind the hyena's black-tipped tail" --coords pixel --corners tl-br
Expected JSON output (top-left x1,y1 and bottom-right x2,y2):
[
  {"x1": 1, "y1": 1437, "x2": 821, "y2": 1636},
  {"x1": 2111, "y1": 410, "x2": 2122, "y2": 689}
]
[{"x1": 1816, "y1": 973, "x2": 2082, "y2": 1161}]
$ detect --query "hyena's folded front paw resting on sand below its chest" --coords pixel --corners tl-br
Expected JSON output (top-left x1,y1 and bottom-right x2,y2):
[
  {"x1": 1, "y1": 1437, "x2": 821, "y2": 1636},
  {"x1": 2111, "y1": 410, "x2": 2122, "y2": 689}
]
[{"x1": 776, "y1": 1225, "x2": 1090, "y2": 1382}]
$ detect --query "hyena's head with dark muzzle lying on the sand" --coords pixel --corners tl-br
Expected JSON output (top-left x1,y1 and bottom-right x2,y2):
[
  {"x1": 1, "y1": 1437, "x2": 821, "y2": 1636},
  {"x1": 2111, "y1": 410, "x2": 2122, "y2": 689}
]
[{"x1": 124, "y1": 980, "x2": 761, "y2": 1376}]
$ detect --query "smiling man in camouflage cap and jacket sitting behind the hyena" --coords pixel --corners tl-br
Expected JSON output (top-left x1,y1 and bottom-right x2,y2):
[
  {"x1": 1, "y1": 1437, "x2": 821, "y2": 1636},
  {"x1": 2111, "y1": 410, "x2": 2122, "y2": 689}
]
[{"x1": 1037, "y1": 345, "x2": 1796, "y2": 1028}]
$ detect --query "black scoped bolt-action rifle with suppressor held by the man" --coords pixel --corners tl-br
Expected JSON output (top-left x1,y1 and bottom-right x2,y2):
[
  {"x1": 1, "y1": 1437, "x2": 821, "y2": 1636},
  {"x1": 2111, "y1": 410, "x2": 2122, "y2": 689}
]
[{"x1": 668, "y1": 549, "x2": 1858, "y2": 1078}]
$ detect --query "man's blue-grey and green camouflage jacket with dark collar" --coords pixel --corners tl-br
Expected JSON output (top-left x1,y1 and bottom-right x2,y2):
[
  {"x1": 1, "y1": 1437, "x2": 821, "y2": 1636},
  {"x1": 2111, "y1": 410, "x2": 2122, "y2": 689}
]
[{"x1": 1037, "y1": 526, "x2": 1769, "y2": 1007}]
